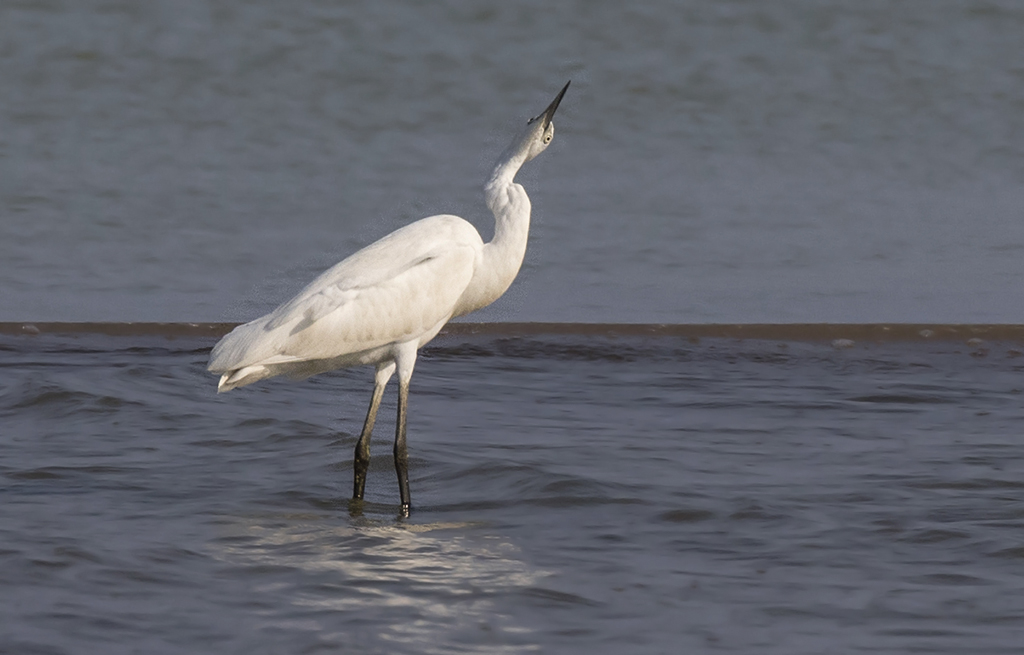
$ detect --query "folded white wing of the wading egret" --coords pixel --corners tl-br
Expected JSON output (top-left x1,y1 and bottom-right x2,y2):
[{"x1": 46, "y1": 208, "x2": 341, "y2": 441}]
[{"x1": 209, "y1": 215, "x2": 482, "y2": 373}]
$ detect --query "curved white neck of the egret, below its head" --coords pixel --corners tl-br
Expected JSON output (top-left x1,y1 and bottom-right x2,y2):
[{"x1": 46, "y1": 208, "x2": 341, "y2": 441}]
[{"x1": 457, "y1": 144, "x2": 530, "y2": 314}]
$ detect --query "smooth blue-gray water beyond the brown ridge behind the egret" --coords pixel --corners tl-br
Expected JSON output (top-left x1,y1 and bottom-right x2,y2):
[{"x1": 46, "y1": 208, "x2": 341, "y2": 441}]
[{"x1": 0, "y1": 0, "x2": 1024, "y2": 322}]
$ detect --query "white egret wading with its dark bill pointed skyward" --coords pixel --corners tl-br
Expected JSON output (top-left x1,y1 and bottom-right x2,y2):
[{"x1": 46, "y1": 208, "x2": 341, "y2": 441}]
[{"x1": 208, "y1": 83, "x2": 569, "y2": 515}]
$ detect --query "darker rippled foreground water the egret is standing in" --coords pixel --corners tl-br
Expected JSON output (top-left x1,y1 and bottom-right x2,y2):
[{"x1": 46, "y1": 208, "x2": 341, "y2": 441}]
[{"x1": 0, "y1": 334, "x2": 1024, "y2": 655}]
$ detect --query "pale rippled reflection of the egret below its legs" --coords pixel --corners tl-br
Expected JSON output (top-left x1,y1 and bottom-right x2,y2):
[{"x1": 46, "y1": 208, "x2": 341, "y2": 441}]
[{"x1": 216, "y1": 515, "x2": 547, "y2": 653}]
